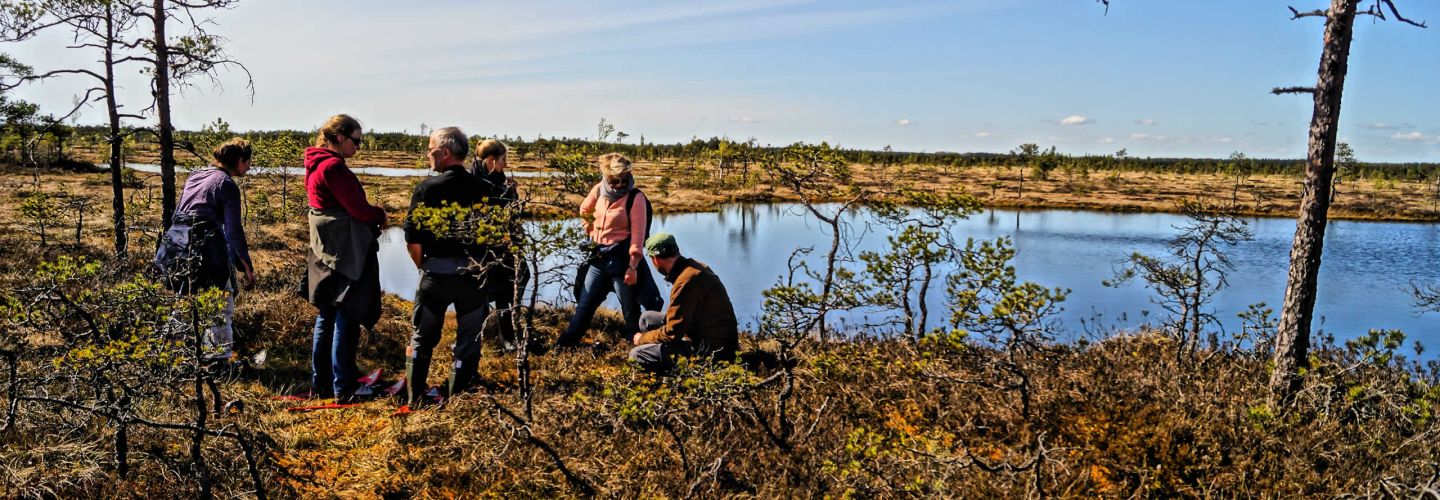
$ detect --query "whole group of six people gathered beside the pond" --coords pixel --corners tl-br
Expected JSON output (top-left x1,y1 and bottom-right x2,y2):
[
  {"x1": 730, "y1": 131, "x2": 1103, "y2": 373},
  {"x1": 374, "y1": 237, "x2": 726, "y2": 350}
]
[{"x1": 156, "y1": 115, "x2": 739, "y2": 405}]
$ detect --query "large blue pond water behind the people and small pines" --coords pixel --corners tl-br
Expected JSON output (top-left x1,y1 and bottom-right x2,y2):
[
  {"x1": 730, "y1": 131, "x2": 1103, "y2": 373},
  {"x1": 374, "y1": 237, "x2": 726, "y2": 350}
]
[{"x1": 382, "y1": 205, "x2": 1440, "y2": 357}]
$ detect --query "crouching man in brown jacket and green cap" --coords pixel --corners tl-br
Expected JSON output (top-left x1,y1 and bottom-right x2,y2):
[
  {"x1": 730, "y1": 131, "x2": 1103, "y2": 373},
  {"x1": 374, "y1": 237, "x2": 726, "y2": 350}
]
[{"x1": 629, "y1": 232, "x2": 740, "y2": 372}]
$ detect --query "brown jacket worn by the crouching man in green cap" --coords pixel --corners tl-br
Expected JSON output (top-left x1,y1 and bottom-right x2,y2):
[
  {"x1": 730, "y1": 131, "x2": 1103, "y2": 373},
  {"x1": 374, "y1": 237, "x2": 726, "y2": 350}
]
[{"x1": 639, "y1": 256, "x2": 740, "y2": 354}]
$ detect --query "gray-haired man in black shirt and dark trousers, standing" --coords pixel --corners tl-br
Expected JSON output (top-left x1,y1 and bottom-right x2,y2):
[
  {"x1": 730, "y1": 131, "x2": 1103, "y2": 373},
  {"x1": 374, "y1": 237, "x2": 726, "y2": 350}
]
[{"x1": 405, "y1": 127, "x2": 490, "y2": 405}]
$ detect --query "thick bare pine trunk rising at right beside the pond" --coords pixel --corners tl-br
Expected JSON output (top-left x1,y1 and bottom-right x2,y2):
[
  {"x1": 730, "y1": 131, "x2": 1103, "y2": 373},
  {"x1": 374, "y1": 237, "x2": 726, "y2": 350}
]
[{"x1": 1270, "y1": 0, "x2": 1359, "y2": 401}]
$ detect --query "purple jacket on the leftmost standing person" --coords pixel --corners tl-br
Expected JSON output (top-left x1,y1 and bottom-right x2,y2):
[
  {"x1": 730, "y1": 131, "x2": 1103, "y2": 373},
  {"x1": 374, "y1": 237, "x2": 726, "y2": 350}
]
[{"x1": 176, "y1": 167, "x2": 255, "y2": 269}]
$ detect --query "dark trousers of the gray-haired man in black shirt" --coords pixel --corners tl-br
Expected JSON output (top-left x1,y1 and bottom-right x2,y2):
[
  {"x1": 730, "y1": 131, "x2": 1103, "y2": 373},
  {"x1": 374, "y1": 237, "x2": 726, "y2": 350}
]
[{"x1": 405, "y1": 271, "x2": 490, "y2": 403}]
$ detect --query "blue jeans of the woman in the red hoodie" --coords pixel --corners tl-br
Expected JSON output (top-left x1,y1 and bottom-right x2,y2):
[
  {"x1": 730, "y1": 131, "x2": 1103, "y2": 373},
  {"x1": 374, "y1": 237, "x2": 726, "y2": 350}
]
[{"x1": 310, "y1": 305, "x2": 360, "y2": 396}]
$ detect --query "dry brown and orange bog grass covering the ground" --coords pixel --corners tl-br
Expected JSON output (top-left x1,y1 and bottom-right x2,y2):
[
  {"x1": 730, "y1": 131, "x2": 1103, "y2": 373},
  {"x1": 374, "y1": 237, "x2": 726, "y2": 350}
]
[{"x1": 0, "y1": 166, "x2": 1440, "y2": 497}]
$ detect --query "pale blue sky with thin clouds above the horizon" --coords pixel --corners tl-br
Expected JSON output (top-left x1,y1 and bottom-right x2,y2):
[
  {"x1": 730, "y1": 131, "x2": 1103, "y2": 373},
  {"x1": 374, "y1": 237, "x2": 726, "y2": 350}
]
[{"x1": 0, "y1": 0, "x2": 1440, "y2": 161}]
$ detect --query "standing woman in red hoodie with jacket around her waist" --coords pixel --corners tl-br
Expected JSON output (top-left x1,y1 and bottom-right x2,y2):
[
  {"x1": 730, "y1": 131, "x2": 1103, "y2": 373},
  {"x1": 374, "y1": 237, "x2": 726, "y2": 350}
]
[{"x1": 305, "y1": 115, "x2": 386, "y2": 401}]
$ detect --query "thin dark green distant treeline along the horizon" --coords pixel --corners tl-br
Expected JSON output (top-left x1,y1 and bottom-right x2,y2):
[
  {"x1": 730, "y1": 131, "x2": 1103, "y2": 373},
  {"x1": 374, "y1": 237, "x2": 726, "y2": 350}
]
[{"x1": 39, "y1": 121, "x2": 1440, "y2": 182}]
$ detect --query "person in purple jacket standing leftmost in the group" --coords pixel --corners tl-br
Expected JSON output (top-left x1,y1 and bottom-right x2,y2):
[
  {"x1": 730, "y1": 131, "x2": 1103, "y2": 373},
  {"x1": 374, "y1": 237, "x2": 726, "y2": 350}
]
[{"x1": 156, "y1": 137, "x2": 255, "y2": 360}]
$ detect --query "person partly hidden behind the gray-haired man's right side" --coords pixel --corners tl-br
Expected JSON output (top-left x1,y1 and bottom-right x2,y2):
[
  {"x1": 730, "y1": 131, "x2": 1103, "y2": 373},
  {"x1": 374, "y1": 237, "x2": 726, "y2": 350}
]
[{"x1": 471, "y1": 138, "x2": 528, "y2": 352}]
